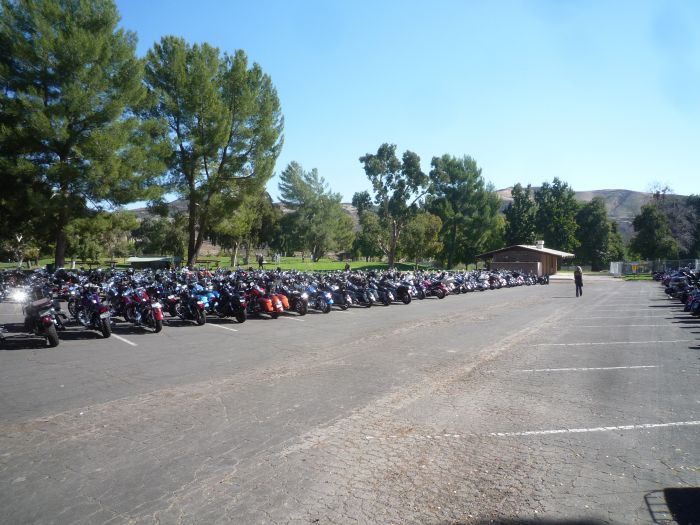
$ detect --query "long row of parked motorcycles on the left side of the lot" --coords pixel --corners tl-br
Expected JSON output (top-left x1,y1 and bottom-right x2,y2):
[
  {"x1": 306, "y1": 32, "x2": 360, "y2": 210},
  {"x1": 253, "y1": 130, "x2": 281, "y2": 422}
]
[{"x1": 0, "y1": 269, "x2": 549, "y2": 346}]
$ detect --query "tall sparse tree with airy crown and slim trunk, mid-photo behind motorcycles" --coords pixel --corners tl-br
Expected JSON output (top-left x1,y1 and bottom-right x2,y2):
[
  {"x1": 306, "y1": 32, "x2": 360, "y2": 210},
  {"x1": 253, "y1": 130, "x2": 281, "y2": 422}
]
[{"x1": 360, "y1": 143, "x2": 428, "y2": 267}]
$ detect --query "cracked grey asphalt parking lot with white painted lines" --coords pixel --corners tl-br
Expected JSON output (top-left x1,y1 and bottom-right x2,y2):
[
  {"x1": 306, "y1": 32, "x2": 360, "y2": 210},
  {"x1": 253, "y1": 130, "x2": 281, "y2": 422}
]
[{"x1": 0, "y1": 279, "x2": 700, "y2": 524}]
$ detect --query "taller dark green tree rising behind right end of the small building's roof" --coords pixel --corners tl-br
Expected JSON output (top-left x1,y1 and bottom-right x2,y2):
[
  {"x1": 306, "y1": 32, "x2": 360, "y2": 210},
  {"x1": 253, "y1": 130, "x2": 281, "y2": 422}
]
[{"x1": 535, "y1": 177, "x2": 579, "y2": 253}]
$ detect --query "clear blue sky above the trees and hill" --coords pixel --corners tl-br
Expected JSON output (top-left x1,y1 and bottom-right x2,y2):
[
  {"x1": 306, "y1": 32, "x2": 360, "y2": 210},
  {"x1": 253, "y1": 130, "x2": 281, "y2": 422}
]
[{"x1": 117, "y1": 0, "x2": 700, "y2": 201}]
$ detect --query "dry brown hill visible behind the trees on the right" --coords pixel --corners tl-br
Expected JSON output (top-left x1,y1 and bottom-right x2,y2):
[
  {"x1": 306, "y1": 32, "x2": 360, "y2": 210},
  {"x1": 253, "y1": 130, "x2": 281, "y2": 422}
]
[{"x1": 496, "y1": 187, "x2": 683, "y2": 242}]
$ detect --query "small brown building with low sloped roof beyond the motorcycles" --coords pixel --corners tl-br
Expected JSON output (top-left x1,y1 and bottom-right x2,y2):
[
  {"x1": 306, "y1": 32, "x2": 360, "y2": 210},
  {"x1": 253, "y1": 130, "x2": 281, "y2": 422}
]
[{"x1": 477, "y1": 241, "x2": 574, "y2": 277}]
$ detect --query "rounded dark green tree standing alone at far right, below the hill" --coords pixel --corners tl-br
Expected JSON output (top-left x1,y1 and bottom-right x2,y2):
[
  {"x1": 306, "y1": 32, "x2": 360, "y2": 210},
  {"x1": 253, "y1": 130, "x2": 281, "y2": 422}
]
[{"x1": 630, "y1": 203, "x2": 678, "y2": 260}]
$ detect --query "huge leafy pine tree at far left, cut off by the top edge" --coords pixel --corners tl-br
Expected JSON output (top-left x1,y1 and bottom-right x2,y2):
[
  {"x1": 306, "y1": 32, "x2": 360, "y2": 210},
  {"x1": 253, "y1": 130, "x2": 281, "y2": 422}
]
[{"x1": 0, "y1": 0, "x2": 168, "y2": 265}]
